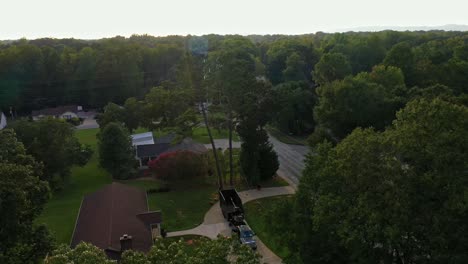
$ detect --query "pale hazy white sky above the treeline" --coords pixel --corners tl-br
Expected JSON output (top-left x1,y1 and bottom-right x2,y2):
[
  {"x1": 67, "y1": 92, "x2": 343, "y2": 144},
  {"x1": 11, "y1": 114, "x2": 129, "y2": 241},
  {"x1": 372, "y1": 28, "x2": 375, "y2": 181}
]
[{"x1": 0, "y1": 0, "x2": 468, "y2": 39}]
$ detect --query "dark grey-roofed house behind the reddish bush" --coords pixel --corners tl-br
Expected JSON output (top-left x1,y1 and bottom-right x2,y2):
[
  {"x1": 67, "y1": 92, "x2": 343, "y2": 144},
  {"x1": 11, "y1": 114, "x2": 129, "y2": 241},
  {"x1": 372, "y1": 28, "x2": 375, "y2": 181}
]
[{"x1": 136, "y1": 135, "x2": 208, "y2": 169}]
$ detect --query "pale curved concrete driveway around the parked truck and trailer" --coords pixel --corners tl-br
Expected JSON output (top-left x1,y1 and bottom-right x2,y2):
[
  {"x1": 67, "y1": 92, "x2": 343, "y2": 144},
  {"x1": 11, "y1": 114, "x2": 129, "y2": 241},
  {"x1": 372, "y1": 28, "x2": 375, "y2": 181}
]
[{"x1": 167, "y1": 186, "x2": 295, "y2": 264}]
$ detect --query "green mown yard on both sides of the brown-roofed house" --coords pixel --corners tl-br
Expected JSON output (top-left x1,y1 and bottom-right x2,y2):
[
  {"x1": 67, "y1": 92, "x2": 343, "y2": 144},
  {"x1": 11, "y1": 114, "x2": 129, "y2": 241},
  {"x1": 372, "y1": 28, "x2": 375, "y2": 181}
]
[{"x1": 36, "y1": 129, "x2": 216, "y2": 244}]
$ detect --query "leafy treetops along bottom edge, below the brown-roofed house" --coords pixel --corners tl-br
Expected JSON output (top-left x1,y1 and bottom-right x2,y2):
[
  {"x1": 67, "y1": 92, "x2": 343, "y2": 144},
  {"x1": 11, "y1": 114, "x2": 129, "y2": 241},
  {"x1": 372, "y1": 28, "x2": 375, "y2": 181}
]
[{"x1": 45, "y1": 236, "x2": 260, "y2": 264}]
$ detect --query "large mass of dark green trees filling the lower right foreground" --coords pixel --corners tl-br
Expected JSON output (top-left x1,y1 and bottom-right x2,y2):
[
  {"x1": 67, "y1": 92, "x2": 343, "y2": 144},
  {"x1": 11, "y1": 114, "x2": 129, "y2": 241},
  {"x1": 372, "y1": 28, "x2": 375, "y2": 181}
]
[{"x1": 284, "y1": 98, "x2": 468, "y2": 263}]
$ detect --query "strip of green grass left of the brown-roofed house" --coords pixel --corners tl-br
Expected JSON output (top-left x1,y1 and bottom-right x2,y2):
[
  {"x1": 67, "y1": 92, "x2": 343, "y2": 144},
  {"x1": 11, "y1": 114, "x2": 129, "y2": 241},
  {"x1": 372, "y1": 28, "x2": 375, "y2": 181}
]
[{"x1": 36, "y1": 129, "x2": 112, "y2": 244}]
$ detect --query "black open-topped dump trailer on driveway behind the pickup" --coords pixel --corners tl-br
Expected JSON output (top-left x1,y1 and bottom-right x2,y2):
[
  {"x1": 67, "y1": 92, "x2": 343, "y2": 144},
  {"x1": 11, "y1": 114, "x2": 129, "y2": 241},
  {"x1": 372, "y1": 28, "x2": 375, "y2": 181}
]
[{"x1": 219, "y1": 189, "x2": 244, "y2": 226}]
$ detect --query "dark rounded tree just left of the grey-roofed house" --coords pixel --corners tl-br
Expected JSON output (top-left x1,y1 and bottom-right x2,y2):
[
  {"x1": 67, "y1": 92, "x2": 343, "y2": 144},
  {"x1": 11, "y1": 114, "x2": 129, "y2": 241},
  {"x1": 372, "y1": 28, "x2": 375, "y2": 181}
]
[{"x1": 98, "y1": 122, "x2": 136, "y2": 179}]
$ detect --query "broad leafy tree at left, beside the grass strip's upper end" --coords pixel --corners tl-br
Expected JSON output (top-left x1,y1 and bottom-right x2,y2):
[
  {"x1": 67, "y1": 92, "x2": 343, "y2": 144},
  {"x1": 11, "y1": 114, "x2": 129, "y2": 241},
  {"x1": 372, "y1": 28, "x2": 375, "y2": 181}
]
[{"x1": 12, "y1": 118, "x2": 92, "y2": 189}]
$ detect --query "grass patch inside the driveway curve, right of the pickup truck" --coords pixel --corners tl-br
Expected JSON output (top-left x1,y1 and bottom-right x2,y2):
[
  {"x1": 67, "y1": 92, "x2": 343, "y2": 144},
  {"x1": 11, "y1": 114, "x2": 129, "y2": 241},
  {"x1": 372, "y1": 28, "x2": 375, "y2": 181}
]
[{"x1": 244, "y1": 196, "x2": 290, "y2": 258}]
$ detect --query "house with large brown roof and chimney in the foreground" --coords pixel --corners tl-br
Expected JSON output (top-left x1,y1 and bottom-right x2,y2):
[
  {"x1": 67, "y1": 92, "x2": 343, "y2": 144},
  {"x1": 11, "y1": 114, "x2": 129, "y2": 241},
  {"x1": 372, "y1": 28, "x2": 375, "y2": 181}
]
[{"x1": 71, "y1": 182, "x2": 162, "y2": 259}]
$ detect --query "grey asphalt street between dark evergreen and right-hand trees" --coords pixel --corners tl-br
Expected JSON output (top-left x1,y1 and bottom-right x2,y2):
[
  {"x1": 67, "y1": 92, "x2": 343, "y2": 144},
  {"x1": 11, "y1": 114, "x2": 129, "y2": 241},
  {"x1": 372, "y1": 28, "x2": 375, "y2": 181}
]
[{"x1": 269, "y1": 135, "x2": 309, "y2": 188}]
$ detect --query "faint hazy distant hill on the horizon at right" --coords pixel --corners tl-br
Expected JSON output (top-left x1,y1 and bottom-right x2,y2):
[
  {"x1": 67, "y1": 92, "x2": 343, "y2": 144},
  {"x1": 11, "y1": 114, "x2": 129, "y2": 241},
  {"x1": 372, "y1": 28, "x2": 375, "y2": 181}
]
[{"x1": 337, "y1": 24, "x2": 468, "y2": 32}]
